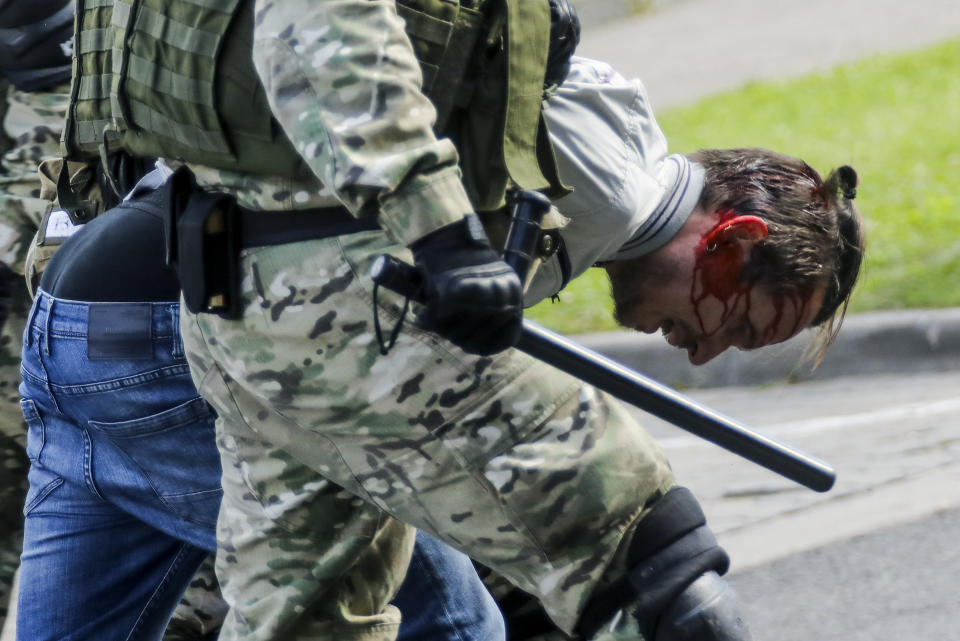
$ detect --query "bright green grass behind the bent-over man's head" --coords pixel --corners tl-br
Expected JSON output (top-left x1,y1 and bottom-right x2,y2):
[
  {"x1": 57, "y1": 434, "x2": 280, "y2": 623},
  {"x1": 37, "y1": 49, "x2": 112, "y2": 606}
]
[{"x1": 528, "y1": 40, "x2": 960, "y2": 334}]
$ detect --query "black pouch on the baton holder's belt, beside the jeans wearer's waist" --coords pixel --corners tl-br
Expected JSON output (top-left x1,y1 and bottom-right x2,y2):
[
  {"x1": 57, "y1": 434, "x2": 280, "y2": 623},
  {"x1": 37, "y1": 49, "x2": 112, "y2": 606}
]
[{"x1": 175, "y1": 189, "x2": 242, "y2": 319}]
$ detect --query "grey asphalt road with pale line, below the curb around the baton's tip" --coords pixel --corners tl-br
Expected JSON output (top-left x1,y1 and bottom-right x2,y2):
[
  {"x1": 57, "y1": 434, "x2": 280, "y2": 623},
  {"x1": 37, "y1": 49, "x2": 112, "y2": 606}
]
[{"x1": 624, "y1": 367, "x2": 960, "y2": 641}]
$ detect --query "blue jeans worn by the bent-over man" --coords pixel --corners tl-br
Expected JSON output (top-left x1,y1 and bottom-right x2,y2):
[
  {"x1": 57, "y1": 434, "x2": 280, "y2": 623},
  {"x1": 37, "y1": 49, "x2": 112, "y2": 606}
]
[{"x1": 17, "y1": 291, "x2": 504, "y2": 641}]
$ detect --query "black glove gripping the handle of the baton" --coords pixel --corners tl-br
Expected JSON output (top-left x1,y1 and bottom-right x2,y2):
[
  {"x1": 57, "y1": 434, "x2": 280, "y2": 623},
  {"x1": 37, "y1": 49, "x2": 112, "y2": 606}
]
[{"x1": 410, "y1": 214, "x2": 523, "y2": 356}]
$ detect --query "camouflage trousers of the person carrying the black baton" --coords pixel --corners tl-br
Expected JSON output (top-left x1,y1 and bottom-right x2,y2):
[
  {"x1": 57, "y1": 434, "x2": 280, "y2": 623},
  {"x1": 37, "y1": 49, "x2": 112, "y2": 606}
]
[{"x1": 182, "y1": 232, "x2": 673, "y2": 640}]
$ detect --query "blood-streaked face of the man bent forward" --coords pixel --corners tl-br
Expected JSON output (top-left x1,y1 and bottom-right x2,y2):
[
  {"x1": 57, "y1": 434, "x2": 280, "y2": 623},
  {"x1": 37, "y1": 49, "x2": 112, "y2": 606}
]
[{"x1": 607, "y1": 214, "x2": 825, "y2": 365}]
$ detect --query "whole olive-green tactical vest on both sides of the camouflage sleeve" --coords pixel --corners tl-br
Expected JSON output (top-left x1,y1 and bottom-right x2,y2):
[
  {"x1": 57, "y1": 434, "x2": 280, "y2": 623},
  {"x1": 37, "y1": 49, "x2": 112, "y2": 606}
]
[{"x1": 64, "y1": 0, "x2": 564, "y2": 210}]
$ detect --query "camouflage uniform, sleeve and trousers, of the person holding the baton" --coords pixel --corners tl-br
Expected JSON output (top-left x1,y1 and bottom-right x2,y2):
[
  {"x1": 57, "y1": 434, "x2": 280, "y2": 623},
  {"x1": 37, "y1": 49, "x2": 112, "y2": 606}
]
[{"x1": 174, "y1": 0, "x2": 673, "y2": 640}]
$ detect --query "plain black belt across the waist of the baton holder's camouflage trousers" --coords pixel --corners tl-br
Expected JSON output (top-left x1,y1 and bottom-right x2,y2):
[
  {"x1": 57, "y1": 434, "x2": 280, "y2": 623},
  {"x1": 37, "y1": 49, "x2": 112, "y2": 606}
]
[{"x1": 236, "y1": 207, "x2": 380, "y2": 249}]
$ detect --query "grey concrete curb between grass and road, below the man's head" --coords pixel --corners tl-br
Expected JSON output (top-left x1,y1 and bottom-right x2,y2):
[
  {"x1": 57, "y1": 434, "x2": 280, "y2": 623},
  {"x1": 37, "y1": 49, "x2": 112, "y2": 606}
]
[{"x1": 573, "y1": 308, "x2": 960, "y2": 389}]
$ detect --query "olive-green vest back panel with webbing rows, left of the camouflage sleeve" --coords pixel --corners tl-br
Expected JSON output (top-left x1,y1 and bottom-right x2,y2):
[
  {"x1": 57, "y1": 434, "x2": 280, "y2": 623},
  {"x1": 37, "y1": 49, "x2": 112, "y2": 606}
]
[{"x1": 66, "y1": 0, "x2": 304, "y2": 174}]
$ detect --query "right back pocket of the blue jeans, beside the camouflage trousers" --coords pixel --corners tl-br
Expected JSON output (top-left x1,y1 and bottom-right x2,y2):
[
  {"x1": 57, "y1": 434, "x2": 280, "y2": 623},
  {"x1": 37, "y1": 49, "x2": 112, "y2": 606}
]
[{"x1": 89, "y1": 397, "x2": 221, "y2": 526}]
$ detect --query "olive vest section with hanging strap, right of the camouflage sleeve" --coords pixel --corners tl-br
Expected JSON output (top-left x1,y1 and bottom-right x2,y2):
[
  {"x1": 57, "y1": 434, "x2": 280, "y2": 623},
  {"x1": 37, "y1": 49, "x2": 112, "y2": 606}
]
[{"x1": 397, "y1": 0, "x2": 568, "y2": 211}]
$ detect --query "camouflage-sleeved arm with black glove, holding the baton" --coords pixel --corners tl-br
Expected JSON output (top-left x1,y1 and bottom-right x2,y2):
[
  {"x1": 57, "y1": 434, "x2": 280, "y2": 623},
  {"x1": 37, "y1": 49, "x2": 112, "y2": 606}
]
[{"x1": 253, "y1": 0, "x2": 523, "y2": 354}]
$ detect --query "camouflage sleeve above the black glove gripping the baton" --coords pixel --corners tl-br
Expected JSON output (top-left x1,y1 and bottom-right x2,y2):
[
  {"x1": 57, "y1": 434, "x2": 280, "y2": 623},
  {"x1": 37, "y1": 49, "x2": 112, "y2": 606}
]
[{"x1": 253, "y1": 0, "x2": 472, "y2": 244}]
